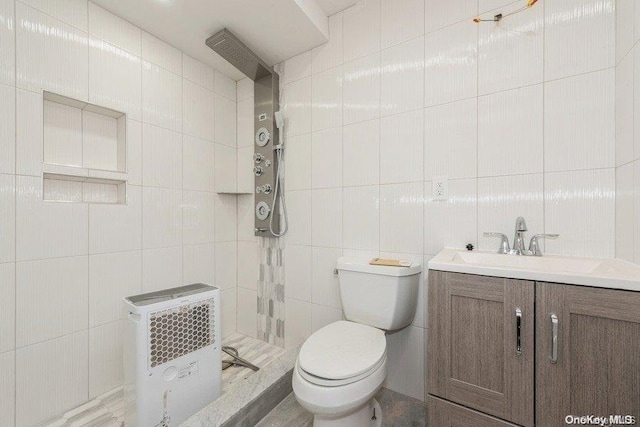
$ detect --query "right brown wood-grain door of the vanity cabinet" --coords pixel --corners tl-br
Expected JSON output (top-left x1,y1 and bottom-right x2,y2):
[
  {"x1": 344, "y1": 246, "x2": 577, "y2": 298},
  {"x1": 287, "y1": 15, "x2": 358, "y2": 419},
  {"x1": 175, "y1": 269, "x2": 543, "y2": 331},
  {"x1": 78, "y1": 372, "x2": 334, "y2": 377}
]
[{"x1": 536, "y1": 283, "x2": 640, "y2": 427}]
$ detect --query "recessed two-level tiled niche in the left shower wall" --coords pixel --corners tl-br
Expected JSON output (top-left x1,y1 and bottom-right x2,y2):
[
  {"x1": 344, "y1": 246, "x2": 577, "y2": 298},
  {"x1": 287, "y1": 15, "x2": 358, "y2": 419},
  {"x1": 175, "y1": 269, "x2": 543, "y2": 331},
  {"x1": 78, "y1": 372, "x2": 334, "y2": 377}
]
[{"x1": 43, "y1": 91, "x2": 127, "y2": 204}]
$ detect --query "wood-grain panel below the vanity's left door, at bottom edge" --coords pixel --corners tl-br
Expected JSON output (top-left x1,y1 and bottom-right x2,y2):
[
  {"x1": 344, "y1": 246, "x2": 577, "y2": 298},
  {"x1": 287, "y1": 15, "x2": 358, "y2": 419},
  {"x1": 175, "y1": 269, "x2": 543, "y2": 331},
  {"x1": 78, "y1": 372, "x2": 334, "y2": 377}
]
[{"x1": 427, "y1": 396, "x2": 516, "y2": 427}]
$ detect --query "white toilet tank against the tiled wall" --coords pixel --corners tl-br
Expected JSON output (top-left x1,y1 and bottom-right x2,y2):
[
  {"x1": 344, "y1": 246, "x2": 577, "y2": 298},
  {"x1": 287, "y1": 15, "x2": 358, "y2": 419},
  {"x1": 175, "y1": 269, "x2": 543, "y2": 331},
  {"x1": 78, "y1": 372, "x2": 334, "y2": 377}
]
[{"x1": 337, "y1": 257, "x2": 422, "y2": 331}]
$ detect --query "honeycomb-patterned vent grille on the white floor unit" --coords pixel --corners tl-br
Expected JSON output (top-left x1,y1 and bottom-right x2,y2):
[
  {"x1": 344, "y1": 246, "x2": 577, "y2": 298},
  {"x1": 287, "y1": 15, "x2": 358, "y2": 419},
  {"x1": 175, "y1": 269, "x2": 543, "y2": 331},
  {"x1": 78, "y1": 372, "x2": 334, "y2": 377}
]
[{"x1": 149, "y1": 299, "x2": 216, "y2": 368}]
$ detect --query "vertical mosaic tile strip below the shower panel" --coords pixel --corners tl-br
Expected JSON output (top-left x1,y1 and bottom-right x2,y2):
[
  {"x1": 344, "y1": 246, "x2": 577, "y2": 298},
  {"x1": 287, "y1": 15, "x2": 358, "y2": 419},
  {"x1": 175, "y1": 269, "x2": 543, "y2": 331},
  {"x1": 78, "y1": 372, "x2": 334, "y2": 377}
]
[{"x1": 258, "y1": 237, "x2": 284, "y2": 348}]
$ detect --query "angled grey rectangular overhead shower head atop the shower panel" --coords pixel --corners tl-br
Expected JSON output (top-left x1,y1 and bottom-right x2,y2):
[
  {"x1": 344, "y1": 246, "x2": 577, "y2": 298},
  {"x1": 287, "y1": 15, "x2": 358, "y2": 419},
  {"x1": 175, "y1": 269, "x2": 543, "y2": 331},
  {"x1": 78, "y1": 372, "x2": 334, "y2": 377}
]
[{"x1": 205, "y1": 28, "x2": 273, "y2": 81}]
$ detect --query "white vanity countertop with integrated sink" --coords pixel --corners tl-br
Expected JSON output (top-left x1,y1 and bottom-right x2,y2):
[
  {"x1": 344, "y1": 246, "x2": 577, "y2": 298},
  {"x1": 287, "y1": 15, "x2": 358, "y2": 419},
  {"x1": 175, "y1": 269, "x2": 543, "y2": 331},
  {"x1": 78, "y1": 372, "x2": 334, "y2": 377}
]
[{"x1": 429, "y1": 248, "x2": 640, "y2": 291}]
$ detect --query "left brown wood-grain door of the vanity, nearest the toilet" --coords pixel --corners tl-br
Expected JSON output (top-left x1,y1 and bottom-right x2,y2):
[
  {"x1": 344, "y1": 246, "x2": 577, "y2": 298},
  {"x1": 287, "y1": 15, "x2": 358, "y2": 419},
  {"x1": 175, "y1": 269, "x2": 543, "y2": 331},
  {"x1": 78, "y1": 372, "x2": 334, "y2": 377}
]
[{"x1": 427, "y1": 271, "x2": 535, "y2": 426}]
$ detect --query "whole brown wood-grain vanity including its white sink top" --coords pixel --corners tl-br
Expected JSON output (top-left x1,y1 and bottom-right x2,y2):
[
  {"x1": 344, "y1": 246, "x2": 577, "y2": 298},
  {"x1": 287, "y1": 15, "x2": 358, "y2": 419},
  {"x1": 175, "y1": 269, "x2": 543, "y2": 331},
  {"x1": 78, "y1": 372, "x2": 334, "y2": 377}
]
[{"x1": 426, "y1": 249, "x2": 640, "y2": 427}]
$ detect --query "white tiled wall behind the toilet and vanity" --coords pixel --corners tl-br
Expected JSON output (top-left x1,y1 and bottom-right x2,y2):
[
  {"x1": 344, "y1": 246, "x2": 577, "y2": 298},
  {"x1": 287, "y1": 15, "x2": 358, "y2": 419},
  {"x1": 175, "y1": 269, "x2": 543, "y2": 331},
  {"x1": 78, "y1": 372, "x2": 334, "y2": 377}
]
[{"x1": 283, "y1": 0, "x2": 620, "y2": 399}]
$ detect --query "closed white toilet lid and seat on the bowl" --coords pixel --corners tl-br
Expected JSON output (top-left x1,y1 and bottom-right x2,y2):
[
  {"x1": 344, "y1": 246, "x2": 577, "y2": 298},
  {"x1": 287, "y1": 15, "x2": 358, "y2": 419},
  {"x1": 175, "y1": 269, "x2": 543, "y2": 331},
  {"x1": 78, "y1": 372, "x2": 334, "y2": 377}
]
[{"x1": 296, "y1": 320, "x2": 387, "y2": 387}]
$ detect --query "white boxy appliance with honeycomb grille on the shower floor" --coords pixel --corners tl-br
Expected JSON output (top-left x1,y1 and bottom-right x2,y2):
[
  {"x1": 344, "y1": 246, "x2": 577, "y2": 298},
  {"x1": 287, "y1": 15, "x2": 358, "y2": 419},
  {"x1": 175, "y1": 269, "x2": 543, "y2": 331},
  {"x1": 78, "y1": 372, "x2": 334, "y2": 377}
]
[{"x1": 124, "y1": 283, "x2": 222, "y2": 427}]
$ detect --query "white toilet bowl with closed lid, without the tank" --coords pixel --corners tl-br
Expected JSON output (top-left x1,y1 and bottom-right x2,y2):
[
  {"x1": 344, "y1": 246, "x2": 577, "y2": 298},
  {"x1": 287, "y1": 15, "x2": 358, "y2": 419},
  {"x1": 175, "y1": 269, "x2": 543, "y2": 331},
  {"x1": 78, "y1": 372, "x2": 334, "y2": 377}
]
[{"x1": 293, "y1": 321, "x2": 387, "y2": 427}]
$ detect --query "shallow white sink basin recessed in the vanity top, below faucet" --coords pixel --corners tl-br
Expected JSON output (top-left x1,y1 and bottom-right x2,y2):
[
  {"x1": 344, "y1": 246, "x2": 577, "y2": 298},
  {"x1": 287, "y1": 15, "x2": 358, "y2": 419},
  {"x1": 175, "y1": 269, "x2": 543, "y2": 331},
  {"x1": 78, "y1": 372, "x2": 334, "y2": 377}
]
[{"x1": 455, "y1": 252, "x2": 601, "y2": 273}]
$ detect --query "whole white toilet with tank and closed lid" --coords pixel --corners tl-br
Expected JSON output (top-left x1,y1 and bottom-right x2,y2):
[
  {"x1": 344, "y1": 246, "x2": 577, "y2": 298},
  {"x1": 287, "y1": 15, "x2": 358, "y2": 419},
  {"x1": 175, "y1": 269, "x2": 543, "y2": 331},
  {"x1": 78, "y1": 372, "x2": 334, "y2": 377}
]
[{"x1": 293, "y1": 257, "x2": 421, "y2": 427}]
